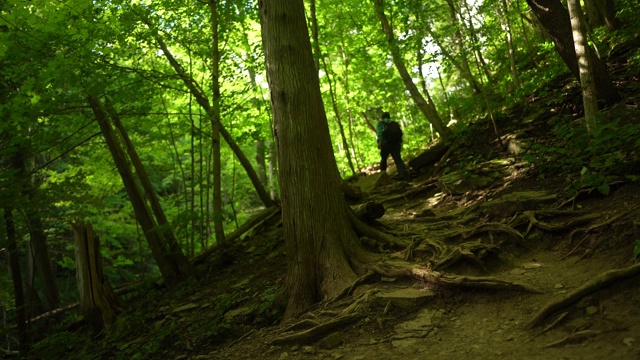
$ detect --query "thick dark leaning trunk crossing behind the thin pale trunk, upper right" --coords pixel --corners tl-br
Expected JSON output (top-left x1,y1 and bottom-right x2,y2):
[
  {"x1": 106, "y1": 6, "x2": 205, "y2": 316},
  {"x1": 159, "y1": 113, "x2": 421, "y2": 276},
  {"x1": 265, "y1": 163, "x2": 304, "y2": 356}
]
[{"x1": 527, "y1": 0, "x2": 622, "y2": 105}]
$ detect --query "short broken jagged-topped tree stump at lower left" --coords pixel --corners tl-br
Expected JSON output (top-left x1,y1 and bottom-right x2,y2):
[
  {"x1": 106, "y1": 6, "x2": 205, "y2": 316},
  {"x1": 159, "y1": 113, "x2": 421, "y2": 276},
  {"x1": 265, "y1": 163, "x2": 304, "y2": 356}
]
[{"x1": 73, "y1": 221, "x2": 120, "y2": 334}]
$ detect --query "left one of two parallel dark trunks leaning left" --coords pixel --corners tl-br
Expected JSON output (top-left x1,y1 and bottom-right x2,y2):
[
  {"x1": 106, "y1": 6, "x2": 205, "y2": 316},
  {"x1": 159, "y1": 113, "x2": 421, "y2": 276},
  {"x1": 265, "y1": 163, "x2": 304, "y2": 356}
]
[{"x1": 88, "y1": 96, "x2": 193, "y2": 289}]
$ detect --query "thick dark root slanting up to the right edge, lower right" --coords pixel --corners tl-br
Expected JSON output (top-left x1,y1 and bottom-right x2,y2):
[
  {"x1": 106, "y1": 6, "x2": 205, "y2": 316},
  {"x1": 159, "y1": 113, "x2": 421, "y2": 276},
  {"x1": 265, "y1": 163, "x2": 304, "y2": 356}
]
[{"x1": 527, "y1": 264, "x2": 640, "y2": 328}]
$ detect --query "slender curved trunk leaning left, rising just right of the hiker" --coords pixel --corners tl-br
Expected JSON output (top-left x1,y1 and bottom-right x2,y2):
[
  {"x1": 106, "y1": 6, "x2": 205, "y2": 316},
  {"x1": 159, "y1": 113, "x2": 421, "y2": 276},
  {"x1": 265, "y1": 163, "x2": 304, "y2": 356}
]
[{"x1": 373, "y1": 0, "x2": 452, "y2": 139}]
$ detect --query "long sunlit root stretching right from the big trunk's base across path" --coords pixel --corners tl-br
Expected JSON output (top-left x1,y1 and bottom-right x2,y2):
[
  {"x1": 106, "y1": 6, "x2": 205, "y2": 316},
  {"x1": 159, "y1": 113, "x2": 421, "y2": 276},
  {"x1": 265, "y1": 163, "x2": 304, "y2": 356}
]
[{"x1": 373, "y1": 261, "x2": 542, "y2": 294}]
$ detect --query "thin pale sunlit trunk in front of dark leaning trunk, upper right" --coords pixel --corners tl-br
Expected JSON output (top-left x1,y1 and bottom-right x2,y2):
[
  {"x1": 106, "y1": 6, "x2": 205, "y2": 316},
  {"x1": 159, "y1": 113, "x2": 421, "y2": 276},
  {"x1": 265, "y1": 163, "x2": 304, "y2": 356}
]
[{"x1": 567, "y1": 0, "x2": 598, "y2": 133}]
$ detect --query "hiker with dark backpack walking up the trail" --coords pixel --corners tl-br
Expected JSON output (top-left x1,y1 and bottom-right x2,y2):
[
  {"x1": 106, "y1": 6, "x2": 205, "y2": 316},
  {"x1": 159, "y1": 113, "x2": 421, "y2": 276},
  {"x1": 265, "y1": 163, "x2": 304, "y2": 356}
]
[{"x1": 376, "y1": 111, "x2": 409, "y2": 180}]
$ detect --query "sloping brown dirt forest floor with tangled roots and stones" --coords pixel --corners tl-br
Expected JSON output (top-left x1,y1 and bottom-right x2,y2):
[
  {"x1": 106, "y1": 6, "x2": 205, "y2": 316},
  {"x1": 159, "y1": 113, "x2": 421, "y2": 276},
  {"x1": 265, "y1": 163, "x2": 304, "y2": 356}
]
[{"x1": 26, "y1": 34, "x2": 640, "y2": 360}]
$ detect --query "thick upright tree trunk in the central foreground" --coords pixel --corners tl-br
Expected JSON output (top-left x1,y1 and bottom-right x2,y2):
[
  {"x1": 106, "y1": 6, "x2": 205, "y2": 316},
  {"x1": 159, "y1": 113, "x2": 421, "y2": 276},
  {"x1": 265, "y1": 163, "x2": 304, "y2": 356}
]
[{"x1": 259, "y1": 0, "x2": 359, "y2": 319}]
